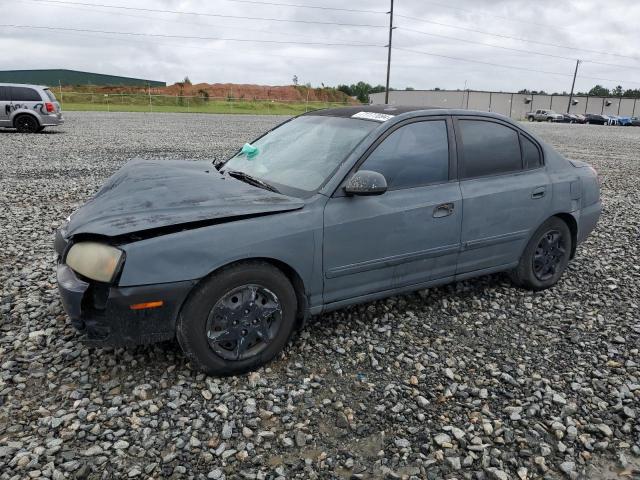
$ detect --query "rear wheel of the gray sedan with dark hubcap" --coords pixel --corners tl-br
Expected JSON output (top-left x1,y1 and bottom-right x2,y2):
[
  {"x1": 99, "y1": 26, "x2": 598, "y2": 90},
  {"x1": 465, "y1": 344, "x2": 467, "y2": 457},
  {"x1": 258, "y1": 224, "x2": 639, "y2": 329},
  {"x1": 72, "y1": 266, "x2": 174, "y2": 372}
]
[{"x1": 511, "y1": 217, "x2": 573, "y2": 290}]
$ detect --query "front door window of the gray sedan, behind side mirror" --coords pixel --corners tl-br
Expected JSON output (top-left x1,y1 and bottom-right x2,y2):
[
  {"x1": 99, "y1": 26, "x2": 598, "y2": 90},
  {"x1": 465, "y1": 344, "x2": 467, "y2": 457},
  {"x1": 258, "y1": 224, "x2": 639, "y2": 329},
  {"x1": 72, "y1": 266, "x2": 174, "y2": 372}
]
[{"x1": 360, "y1": 120, "x2": 449, "y2": 189}]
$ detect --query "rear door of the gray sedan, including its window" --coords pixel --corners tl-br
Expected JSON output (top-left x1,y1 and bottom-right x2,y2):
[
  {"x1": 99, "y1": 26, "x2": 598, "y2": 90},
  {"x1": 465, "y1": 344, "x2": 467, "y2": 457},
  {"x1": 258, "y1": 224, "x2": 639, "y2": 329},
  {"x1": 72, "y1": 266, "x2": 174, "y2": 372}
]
[{"x1": 455, "y1": 116, "x2": 552, "y2": 274}]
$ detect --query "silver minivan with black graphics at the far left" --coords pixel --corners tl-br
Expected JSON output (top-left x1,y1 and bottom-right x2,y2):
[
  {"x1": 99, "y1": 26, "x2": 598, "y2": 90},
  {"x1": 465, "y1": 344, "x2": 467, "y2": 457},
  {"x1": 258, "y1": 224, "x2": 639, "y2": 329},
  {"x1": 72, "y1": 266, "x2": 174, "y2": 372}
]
[{"x1": 0, "y1": 83, "x2": 64, "y2": 133}]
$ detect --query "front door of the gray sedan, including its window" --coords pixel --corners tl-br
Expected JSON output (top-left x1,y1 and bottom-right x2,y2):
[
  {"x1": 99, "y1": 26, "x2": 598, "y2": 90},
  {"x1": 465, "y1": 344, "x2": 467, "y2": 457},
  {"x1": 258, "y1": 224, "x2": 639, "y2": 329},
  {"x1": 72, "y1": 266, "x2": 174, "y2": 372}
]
[{"x1": 323, "y1": 117, "x2": 462, "y2": 304}]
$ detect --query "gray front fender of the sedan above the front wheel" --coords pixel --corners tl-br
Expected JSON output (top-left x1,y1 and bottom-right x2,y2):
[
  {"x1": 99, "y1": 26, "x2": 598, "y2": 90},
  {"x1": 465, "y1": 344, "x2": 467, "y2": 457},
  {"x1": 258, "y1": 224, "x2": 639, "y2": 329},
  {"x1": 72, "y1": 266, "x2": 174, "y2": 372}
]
[{"x1": 118, "y1": 208, "x2": 322, "y2": 304}]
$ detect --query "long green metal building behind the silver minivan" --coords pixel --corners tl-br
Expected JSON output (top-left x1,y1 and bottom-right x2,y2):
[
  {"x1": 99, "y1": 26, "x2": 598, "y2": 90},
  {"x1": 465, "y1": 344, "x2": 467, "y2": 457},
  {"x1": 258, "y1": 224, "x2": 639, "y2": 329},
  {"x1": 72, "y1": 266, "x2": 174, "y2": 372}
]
[{"x1": 0, "y1": 69, "x2": 167, "y2": 87}]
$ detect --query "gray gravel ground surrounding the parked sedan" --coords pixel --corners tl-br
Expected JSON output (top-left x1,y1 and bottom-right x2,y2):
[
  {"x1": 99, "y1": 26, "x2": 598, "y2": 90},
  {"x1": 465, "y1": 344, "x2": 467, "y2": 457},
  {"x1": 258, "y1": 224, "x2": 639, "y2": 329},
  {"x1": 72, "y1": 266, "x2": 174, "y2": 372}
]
[{"x1": 0, "y1": 113, "x2": 640, "y2": 480}]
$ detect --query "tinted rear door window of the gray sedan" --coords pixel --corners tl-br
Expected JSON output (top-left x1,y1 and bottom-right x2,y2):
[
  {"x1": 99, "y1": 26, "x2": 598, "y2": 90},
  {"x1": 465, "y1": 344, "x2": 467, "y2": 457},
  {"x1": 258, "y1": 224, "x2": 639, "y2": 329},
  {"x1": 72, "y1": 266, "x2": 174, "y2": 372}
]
[{"x1": 459, "y1": 120, "x2": 522, "y2": 178}]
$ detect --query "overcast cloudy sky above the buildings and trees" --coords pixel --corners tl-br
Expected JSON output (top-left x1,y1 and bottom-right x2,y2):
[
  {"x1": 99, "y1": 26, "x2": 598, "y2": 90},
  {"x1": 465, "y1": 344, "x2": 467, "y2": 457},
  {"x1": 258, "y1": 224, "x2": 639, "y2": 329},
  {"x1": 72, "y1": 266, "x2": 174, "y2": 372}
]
[{"x1": 0, "y1": 0, "x2": 640, "y2": 92}]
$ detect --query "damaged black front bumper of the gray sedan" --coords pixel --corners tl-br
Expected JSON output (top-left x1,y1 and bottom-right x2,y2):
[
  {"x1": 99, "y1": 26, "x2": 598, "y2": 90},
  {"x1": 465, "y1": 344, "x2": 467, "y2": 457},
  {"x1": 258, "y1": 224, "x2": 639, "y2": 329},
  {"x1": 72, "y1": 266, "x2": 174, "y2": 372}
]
[{"x1": 57, "y1": 263, "x2": 194, "y2": 346}]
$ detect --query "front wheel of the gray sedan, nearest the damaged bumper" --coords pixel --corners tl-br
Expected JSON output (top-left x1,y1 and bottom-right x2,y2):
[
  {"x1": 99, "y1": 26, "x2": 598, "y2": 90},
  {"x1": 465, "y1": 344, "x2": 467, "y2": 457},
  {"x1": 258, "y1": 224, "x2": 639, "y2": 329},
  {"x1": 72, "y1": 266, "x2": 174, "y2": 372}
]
[{"x1": 176, "y1": 262, "x2": 297, "y2": 376}]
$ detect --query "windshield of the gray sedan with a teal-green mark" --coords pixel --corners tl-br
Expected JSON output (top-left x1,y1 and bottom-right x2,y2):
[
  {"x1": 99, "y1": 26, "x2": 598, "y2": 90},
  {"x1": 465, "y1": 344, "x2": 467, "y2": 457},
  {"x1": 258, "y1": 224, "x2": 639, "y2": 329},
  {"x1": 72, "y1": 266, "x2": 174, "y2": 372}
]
[{"x1": 222, "y1": 115, "x2": 379, "y2": 192}]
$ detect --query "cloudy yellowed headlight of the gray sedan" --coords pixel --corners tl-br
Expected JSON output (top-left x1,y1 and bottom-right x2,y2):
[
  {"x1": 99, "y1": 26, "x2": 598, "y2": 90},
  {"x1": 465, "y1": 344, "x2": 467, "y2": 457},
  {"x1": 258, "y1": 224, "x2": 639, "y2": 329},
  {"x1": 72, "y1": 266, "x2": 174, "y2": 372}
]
[{"x1": 65, "y1": 242, "x2": 123, "y2": 283}]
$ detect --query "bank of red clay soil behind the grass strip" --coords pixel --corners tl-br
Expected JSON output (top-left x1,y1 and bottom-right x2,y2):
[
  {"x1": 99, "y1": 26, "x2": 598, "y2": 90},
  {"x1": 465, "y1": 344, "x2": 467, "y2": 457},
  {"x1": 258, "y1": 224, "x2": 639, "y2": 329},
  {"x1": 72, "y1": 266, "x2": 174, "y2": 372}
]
[{"x1": 68, "y1": 83, "x2": 357, "y2": 103}]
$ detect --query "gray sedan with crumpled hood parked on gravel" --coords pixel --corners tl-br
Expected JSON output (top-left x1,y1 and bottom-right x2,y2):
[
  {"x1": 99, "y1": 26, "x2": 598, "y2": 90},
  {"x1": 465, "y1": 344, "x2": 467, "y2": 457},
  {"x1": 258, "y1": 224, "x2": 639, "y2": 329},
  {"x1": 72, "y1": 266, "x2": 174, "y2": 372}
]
[{"x1": 55, "y1": 106, "x2": 601, "y2": 375}]
